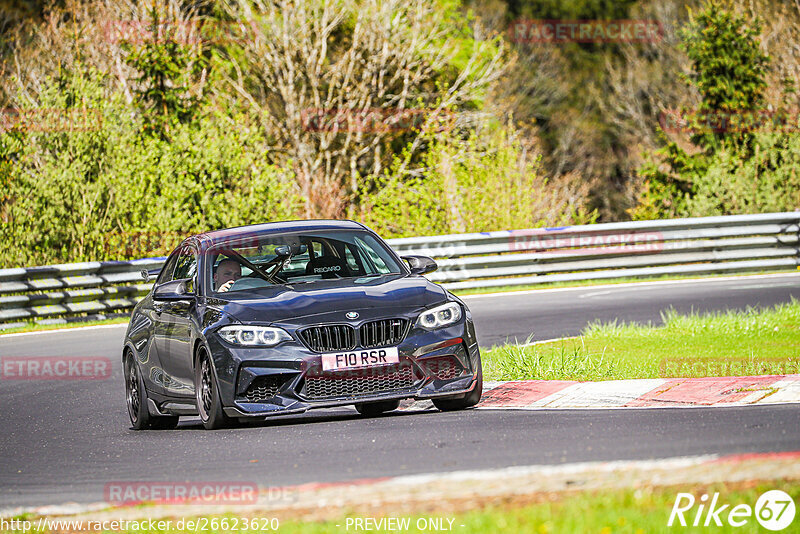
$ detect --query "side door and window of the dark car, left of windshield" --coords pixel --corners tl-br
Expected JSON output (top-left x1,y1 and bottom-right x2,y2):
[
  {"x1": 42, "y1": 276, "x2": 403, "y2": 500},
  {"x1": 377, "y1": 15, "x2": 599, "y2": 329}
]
[{"x1": 155, "y1": 246, "x2": 198, "y2": 397}]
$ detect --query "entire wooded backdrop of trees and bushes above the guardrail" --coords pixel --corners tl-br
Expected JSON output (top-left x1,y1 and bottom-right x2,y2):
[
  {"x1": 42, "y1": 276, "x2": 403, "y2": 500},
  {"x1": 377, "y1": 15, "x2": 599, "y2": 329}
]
[{"x1": 0, "y1": 0, "x2": 800, "y2": 265}]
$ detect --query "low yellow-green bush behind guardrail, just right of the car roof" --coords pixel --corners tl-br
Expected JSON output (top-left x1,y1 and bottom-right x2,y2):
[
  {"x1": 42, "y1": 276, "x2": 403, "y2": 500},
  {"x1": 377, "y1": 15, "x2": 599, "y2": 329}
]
[{"x1": 354, "y1": 123, "x2": 596, "y2": 237}]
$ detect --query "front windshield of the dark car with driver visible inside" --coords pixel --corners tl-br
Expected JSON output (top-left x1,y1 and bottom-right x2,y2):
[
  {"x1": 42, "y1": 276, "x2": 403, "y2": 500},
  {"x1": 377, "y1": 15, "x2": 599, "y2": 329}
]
[{"x1": 209, "y1": 230, "x2": 403, "y2": 292}]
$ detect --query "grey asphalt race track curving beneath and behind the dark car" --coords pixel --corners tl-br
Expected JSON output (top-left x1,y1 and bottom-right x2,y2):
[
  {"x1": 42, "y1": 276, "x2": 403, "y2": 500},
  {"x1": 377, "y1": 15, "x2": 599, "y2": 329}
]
[{"x1": 0, "y1": 274, "x2": 800, "y2": 510}]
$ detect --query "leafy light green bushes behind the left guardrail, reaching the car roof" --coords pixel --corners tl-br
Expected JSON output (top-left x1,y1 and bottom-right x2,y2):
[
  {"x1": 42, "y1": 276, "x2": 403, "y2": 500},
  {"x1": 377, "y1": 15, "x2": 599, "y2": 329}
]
[{"x1": 0, "y1": 67, "x2": 300, "y2": 267}]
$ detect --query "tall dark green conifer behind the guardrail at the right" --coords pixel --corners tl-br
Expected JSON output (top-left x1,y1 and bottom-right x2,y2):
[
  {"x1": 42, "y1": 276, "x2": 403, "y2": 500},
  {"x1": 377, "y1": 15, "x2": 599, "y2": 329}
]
[{"x1": 632, "y1": 0, "x2": 774, "y2": 219}]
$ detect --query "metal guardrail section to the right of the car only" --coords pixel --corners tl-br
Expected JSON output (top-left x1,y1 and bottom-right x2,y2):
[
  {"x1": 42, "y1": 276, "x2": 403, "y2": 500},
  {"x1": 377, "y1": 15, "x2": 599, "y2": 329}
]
[{"x1": 391, "y1": 212, "x2": 800, "y2": 290}]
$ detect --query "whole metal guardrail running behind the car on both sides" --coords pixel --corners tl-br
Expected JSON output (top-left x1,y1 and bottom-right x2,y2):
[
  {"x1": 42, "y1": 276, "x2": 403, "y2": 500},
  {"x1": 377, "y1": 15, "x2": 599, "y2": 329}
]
[{"x1": 0, "y1": 211, "x2": 800, "y2": 328}]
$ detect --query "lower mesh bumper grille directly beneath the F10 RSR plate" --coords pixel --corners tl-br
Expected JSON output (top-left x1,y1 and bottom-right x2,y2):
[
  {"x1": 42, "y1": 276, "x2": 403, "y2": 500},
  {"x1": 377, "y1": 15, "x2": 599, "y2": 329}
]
[{"x1": 305, "y1": 362, "x2": 416, "y2": 399}]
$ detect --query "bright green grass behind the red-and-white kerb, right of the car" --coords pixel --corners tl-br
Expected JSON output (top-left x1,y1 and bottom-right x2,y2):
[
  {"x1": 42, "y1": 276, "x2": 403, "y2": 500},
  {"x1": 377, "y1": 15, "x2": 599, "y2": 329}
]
[{"x1": 482, "y1": 301, "x2": 800, "y2": 380}]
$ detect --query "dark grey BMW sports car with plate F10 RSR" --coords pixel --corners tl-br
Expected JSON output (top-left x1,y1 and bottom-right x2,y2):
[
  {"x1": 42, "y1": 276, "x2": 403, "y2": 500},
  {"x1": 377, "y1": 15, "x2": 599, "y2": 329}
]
[{"x1": 122, "y1": 221, "x2": 482, "y2": 429}]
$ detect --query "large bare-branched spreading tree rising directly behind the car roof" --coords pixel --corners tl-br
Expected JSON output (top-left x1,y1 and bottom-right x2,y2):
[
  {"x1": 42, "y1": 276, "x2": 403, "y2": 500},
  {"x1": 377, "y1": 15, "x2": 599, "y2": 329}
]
[{"x1": 225, "y1": 0, "x2": 503, "y2": 217}]
